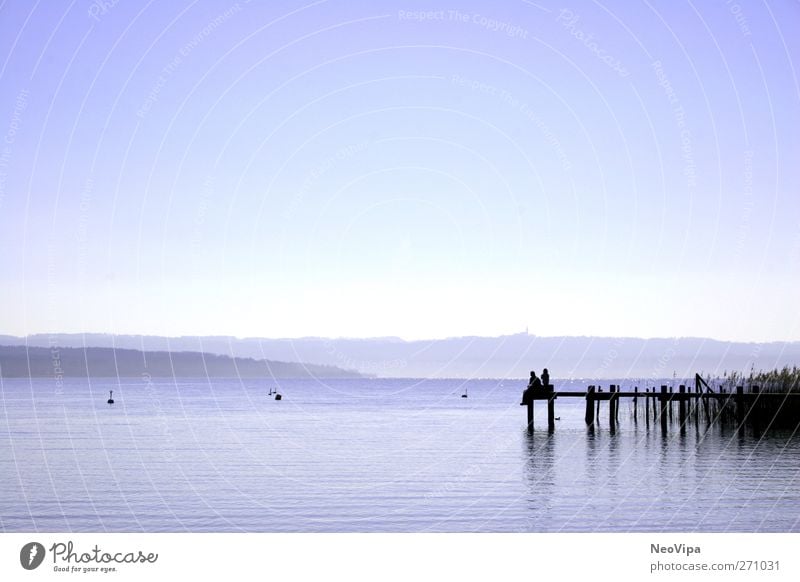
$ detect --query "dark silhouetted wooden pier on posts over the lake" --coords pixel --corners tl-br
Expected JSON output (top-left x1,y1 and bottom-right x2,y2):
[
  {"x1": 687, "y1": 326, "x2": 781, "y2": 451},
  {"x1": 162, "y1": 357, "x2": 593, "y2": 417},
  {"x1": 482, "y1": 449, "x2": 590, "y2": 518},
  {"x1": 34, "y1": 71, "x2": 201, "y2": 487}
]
[{"x1": 520, "y1": 375, "x2": 800, "y2": 432}]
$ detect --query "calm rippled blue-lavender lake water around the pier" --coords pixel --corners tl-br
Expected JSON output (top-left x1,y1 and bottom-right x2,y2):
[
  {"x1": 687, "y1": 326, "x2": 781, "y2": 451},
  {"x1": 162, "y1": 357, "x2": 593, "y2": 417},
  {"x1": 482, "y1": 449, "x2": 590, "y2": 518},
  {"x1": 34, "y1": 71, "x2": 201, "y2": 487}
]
[{"x1": 0, "y1": 378, "x2": 800, "y2": 532}]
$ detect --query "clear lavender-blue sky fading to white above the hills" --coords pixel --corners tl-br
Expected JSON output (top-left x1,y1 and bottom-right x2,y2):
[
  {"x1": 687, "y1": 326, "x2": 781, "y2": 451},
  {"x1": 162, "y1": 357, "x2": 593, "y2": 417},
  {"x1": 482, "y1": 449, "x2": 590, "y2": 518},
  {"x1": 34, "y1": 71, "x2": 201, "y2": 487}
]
[{"x1": 0, "y1": 0, "x2": 800, "y2": 341}]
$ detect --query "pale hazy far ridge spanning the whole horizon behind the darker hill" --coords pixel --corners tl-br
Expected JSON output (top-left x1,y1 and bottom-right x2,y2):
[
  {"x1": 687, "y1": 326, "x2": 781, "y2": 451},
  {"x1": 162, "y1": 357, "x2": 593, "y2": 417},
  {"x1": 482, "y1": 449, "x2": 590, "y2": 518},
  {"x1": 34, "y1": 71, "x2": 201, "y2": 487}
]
[{"x1": 0, "y1": 334, "x2": 800, "y2": 379}]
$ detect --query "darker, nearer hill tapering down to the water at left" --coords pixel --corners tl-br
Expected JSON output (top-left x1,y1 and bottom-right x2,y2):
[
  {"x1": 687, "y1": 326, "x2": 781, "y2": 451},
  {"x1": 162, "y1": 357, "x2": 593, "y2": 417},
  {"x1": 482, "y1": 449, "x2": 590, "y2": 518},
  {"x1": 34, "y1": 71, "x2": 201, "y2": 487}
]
[{"x1": 0, "y1": 346, "x2": 360, "y2": 378}]
